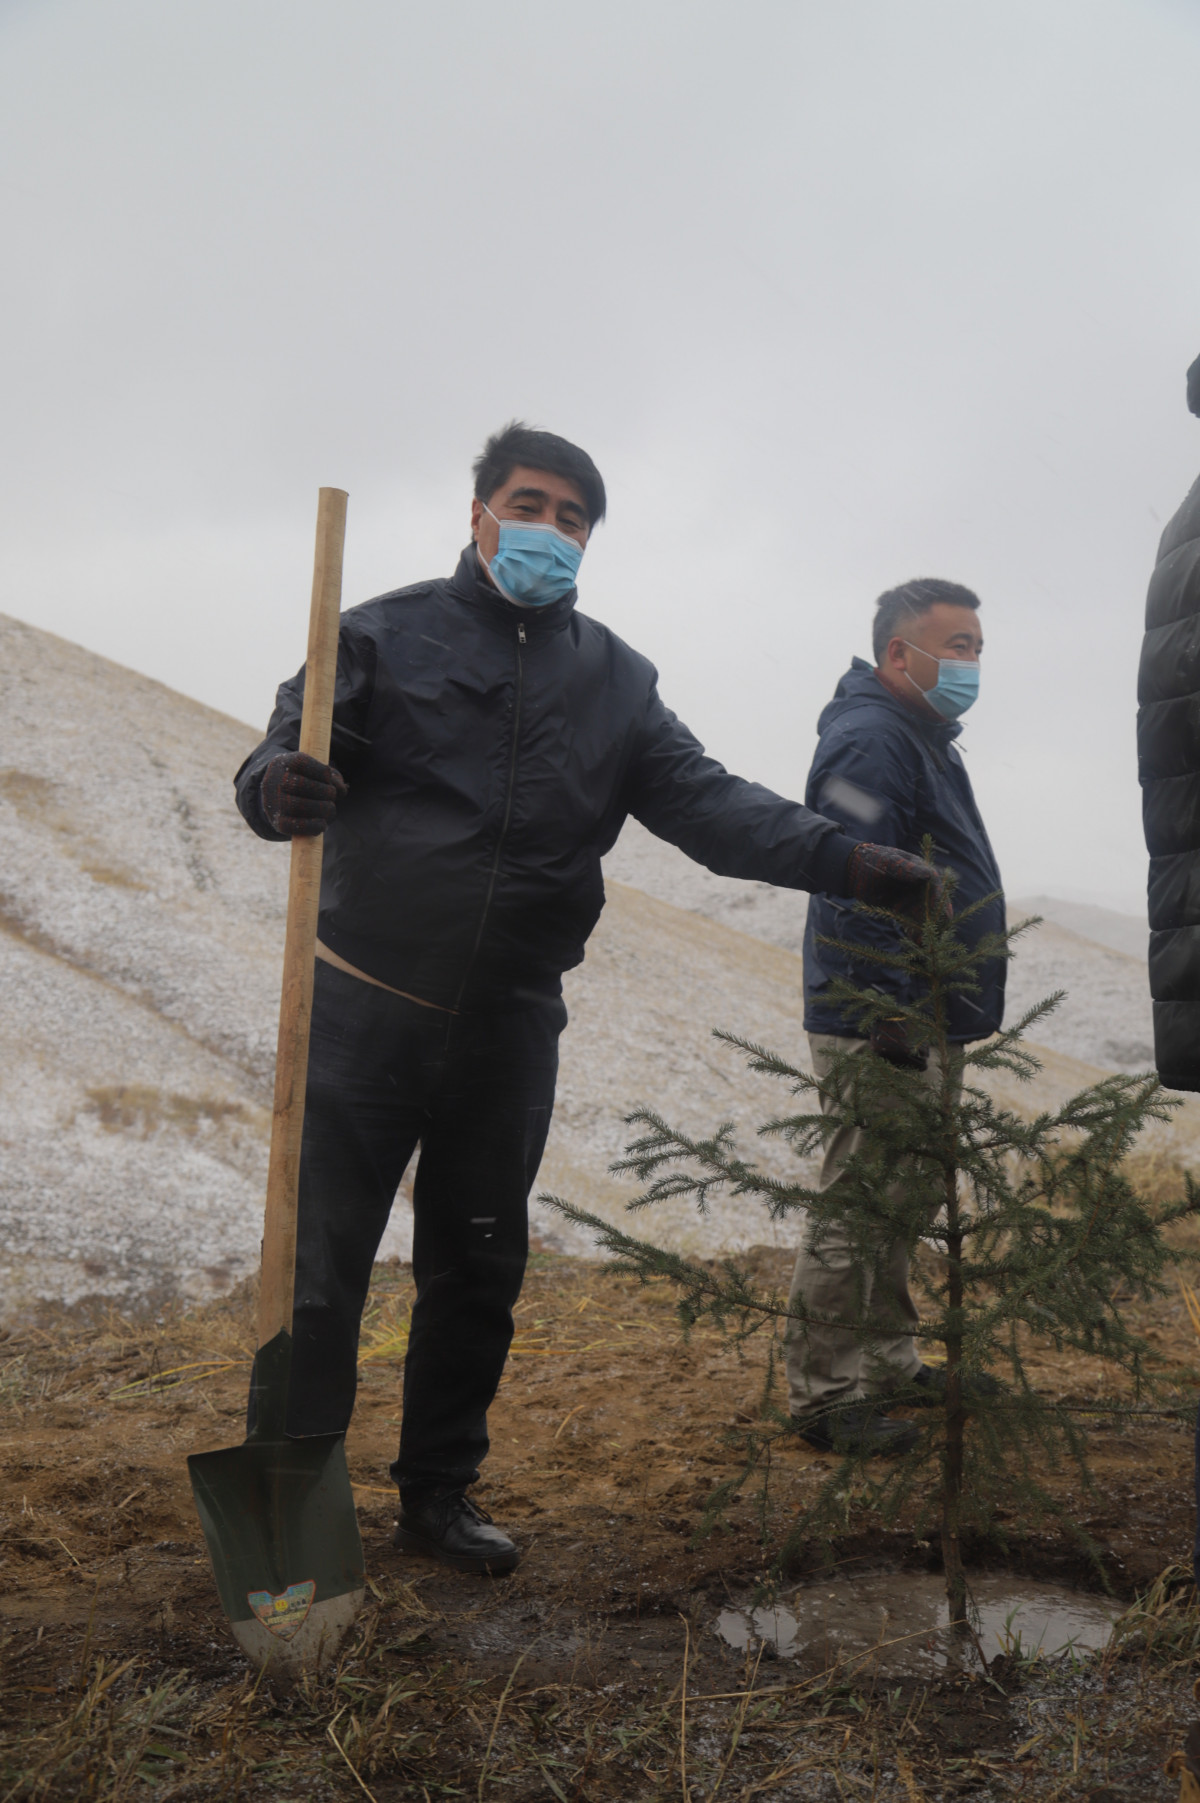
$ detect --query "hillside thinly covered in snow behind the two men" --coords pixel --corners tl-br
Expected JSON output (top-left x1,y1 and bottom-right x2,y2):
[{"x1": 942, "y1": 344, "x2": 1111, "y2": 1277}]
[{"x1": 0, "y1": 617, "x2": 1181, "y2": 1316}]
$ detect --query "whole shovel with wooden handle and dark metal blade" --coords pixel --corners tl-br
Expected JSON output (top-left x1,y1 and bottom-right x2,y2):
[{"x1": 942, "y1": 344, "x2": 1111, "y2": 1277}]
[{"x1": 187, "y1": 489, "x2": 366, "y2": 1684}]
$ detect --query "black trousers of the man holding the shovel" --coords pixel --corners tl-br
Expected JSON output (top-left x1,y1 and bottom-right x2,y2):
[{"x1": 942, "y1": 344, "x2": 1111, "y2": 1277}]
[{"x1": 277, "y1": 959, "x2": 566, "y2": 1489}]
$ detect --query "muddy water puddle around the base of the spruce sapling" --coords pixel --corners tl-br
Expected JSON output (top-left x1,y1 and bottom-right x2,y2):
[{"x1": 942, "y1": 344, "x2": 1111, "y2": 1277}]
[{"x1": 715, "y1": 1572, "x2": 1121, "y2": 1675}]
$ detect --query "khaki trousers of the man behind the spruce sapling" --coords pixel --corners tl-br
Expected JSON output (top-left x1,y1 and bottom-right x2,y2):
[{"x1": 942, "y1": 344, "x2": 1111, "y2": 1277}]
[{"x1": 784, "y1": 1033, "x2": 942, "y2": 1417}]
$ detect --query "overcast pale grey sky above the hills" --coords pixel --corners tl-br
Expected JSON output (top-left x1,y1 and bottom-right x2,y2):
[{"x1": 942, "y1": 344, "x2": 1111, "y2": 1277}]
[{"x1": 0, "y1": 0, "x2": 1200, "y2": 905}]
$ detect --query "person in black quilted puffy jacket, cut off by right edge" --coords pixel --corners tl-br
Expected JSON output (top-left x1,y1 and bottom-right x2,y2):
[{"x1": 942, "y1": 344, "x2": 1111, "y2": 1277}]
[{"x1": 1137, "y1": 357, "x2": 1200, "y2": 1089}]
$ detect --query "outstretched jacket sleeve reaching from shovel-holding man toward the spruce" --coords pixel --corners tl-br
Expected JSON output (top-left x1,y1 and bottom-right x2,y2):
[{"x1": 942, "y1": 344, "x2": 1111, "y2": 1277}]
[{"x1": 625, "y1": 689, "x2": 858, "y2": 894}]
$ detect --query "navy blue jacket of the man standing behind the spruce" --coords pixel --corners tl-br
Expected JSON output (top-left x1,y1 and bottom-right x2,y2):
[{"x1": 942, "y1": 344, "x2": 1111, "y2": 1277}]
[{"x1": 804, "y1": 658, "x2": 1005, "y2": 1042}]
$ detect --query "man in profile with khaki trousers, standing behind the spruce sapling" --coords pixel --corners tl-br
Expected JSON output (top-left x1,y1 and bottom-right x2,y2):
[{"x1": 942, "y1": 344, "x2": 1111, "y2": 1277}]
[{"x1": 787, "y1": 579, "x2": 1005, "y2": 1453}]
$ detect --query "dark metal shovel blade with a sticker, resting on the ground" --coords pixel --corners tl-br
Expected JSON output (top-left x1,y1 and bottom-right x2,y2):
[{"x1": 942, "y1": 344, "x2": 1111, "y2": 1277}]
[{"x1": 187, "y1": 1334, "x2": 366, "y2": 1680}]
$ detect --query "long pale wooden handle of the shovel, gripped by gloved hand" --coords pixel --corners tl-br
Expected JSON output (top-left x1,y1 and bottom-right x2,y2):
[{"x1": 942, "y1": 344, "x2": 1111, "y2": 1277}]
[{"x1": 258, "y1": 489, "x2": 346, "y2": 1345}]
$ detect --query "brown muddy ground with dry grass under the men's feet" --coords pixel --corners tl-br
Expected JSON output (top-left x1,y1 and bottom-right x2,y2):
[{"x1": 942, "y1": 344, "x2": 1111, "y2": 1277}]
[{"x1": 0, "y1": 1251, "x2": 1200, "y2": 1803}]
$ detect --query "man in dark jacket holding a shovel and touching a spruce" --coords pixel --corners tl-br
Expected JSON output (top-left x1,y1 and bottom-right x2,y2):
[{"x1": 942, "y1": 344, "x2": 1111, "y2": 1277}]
[{"x1": 236, "y1": 424, "x2": 933, "y2": 1570}]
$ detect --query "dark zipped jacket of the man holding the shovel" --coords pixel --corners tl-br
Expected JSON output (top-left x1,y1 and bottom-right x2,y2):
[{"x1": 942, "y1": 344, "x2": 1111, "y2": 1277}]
[{"x1": 234, "y1": 546, "x2": 863, "y2": 1008}]
